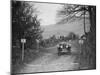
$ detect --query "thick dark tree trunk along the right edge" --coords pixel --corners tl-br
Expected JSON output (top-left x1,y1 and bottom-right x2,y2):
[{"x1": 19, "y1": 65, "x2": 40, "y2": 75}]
[{"x1": 87, "y1": 6, "x2": 96, "y2": 68}]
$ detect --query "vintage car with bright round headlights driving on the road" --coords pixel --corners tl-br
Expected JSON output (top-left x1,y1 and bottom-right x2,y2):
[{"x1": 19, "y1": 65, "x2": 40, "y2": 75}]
[{"x1": 57, "y1": 42, "x2": 71, "y2": 56}]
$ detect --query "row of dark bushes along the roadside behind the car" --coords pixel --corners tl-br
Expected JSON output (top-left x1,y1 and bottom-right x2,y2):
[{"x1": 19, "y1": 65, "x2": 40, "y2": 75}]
[{"x1": 40, "y1": 32, "x2": 79, "y2": 47}]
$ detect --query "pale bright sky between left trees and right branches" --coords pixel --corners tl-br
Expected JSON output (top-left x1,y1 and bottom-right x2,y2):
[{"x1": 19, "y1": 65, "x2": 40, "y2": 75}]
[{"x1": 35, "y1": 3, "x2": 62, "y2": 26}]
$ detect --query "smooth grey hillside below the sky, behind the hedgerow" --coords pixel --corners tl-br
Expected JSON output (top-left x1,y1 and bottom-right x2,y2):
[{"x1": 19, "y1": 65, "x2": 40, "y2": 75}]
[{"x1": 42, "y1": 19, "x2": 90, "y2": 38}]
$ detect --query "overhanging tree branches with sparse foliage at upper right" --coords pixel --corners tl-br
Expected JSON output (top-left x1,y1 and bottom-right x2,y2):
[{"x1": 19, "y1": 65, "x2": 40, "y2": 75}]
[{"x1": 57, "y1": 5, "x2": 88, "y2": 21}]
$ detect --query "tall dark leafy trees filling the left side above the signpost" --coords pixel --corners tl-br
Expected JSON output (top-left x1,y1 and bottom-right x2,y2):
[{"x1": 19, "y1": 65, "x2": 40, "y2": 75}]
[{"x1": 11, "y1": 1, "x2": 42, "y2": 46}]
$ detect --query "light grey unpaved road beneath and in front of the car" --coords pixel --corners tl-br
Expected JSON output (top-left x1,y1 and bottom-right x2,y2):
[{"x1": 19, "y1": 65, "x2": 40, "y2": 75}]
[{"x1": 12, "y1": 40, "x2": 79, "y2": 73}]
